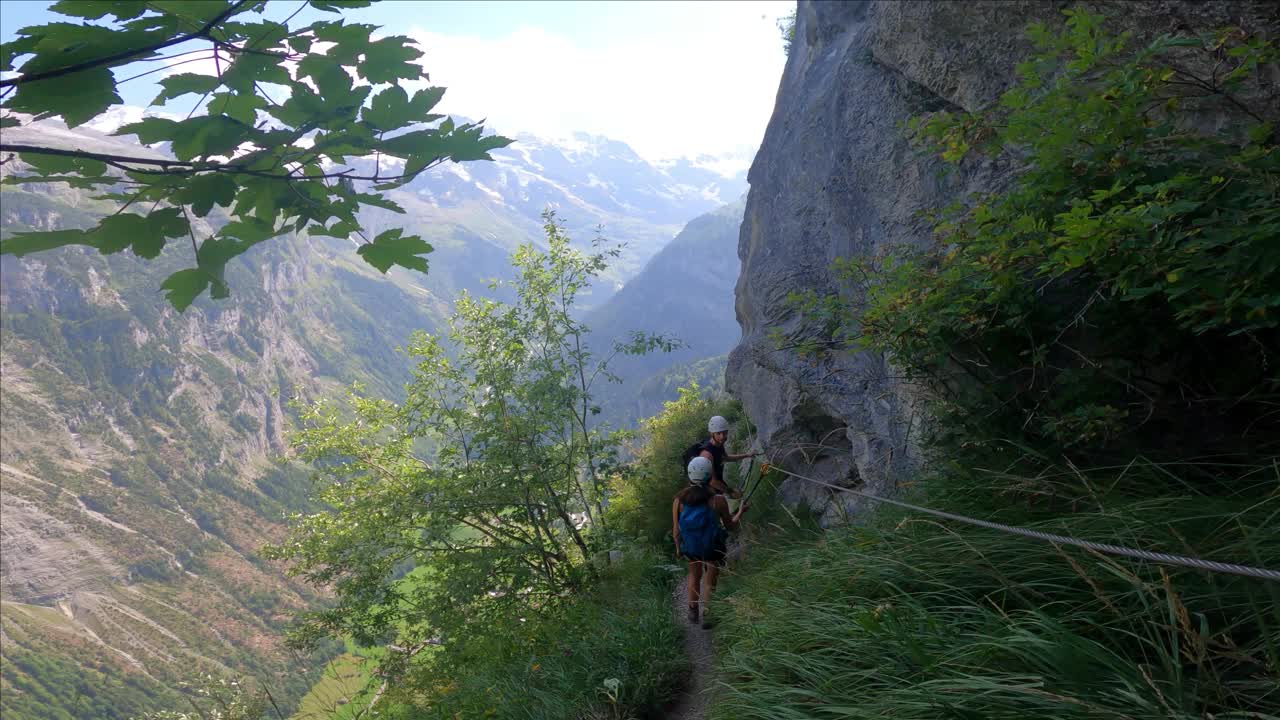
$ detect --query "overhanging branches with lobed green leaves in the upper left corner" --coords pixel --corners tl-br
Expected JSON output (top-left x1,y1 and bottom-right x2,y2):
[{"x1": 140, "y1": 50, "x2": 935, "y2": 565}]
[{"x1": 0, "y1": 0, "x2": 511, "y2": 304}]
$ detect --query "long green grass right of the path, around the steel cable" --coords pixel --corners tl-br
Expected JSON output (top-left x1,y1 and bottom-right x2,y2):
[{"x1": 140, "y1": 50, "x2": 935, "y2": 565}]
[{"x1": 712, "y1": 456, "x2": 1280, "y2": 720}]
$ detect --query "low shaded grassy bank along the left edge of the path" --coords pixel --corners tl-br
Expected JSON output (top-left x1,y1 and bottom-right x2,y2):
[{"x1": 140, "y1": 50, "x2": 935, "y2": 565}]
[{"x1": 383, "y1": 552, "x2": 687, "y2": 720}]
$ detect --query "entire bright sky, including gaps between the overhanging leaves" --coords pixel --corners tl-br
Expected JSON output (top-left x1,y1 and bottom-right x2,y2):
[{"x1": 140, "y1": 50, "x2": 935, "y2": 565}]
[{"x1": 0, "y1": 0, "x2": 795, "y2": 159}]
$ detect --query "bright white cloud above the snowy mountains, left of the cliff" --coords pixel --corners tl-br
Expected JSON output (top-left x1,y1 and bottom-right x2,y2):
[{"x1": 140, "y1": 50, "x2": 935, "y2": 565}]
[{"x1": 408, "y1": 1, "x2": 794, "y2": 160}]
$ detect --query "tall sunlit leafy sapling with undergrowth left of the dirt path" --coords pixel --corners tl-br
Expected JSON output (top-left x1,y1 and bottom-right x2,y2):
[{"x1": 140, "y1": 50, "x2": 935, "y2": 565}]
[{"x1": 257, "y1": 211, "x2": 705, "y2": 717}]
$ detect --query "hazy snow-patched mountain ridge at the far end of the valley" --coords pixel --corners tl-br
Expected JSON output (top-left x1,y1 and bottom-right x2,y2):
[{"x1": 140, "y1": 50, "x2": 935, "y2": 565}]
[{"x1": 67, "y1": 106, "x2": 751, "y2": 305}]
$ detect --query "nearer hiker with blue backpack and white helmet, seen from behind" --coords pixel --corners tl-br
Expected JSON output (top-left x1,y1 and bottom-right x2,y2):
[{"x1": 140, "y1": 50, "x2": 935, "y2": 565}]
[{"x1": 671, "y1": 455, "x2": 748, "y2": 629}]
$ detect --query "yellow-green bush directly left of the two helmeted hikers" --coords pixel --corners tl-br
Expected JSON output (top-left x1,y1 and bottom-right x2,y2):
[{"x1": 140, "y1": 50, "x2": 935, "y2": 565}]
[{"x1": 607, "y1": 384, "x2": 749, "y2": 551}]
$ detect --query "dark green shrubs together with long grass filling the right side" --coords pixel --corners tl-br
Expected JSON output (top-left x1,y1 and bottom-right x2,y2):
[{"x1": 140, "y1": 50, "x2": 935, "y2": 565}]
[{"x1": 742, "y1": 12, "x2": 1280, "y2": 720}]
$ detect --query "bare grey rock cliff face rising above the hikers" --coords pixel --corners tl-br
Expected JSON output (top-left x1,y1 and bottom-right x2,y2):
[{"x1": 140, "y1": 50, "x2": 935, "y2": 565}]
[{"x1": 726, "y1": 0, "x2": 1276, "y2": 521}]
